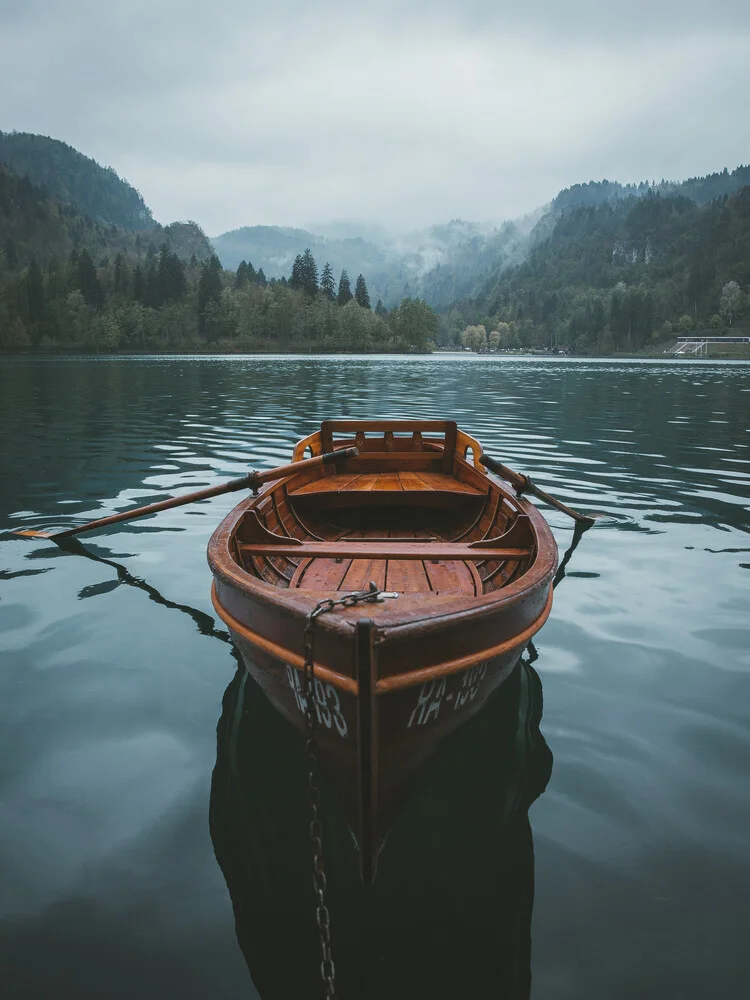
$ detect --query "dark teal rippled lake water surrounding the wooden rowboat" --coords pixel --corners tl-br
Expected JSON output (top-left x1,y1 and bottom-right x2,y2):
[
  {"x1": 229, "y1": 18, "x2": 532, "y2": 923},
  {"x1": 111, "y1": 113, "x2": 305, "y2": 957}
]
[{"x1": 0, "y1": 356, "x2": 750, "y2": 1000}]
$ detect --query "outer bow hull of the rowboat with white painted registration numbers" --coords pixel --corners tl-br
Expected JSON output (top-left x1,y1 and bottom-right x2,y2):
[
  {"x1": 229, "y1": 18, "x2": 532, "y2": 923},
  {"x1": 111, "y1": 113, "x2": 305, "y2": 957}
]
[{"x1": 213, "y1": 586, "x2": 552, "y2": 882}]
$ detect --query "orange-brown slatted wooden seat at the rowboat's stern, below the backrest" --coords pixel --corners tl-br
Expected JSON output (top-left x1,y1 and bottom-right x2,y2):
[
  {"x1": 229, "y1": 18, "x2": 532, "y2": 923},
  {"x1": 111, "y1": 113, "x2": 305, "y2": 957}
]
[{"x1": 287, "y1": 471, "x2": 485, "y2": 510}]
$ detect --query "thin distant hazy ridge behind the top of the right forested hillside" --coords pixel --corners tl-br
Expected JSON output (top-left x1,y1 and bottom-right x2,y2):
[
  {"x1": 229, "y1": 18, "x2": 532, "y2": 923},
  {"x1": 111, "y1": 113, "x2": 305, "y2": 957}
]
[{"x1": 552, "y1": 166, "x2": 750, "y2": 212}]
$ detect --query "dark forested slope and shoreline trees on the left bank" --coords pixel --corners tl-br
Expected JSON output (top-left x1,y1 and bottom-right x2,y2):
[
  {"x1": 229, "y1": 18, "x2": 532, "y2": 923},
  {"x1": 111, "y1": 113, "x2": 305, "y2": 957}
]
[{"x1": 0, "y1": 164, "x2": 437, "y2": 352}]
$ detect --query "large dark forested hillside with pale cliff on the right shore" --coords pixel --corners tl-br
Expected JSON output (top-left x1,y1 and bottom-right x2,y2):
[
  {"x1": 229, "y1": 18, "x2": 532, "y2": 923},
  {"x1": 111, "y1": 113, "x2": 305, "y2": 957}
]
[{"x1": 442, "y1": 188, "x2": 750, "y2": 353}]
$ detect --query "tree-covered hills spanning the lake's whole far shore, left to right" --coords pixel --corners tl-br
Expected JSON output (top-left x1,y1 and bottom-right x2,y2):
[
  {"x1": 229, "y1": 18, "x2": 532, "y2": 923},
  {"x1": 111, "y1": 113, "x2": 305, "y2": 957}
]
[{"x1": 0, "y1": 133, "x2": 750, "y2": 354}]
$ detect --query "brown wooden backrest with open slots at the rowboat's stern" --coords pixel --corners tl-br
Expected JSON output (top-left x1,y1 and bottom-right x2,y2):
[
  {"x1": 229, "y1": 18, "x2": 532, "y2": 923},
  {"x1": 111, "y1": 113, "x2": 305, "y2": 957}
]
[{"x1": 320, "y1": 419, "x2": 457, "y2": 474}]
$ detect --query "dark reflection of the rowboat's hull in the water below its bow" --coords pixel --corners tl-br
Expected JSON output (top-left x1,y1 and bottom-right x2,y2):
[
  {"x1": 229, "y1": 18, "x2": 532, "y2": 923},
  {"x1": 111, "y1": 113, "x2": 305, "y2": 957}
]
[{"x1": 211, "y1": 661, "x2": 552, "y2": 1000}]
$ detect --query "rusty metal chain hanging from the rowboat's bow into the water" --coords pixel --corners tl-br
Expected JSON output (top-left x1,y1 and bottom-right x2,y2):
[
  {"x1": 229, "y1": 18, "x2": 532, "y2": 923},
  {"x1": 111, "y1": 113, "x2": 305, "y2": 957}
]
[{"x1": 303, "y1": 583, "x2": 398, "y2": 1000}]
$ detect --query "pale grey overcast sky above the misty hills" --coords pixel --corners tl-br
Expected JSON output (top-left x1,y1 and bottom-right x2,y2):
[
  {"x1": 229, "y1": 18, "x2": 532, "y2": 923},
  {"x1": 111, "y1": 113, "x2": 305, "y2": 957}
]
[{"x1": 0, "y1": 0, "x2": 750, "y2": 236}]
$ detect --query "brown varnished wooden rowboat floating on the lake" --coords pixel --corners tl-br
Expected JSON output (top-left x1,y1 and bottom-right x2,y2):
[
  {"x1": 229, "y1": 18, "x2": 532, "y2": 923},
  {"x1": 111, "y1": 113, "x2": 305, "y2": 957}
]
[{"x1": 208, "y1": 420, "x2": 557, "y2": 882}]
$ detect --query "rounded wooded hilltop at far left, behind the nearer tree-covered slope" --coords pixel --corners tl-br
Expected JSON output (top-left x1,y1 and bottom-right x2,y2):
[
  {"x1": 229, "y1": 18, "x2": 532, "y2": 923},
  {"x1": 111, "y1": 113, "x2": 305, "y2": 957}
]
[{"x1": 0, "y1": 132, "x2": 155, "y2": 230}]
